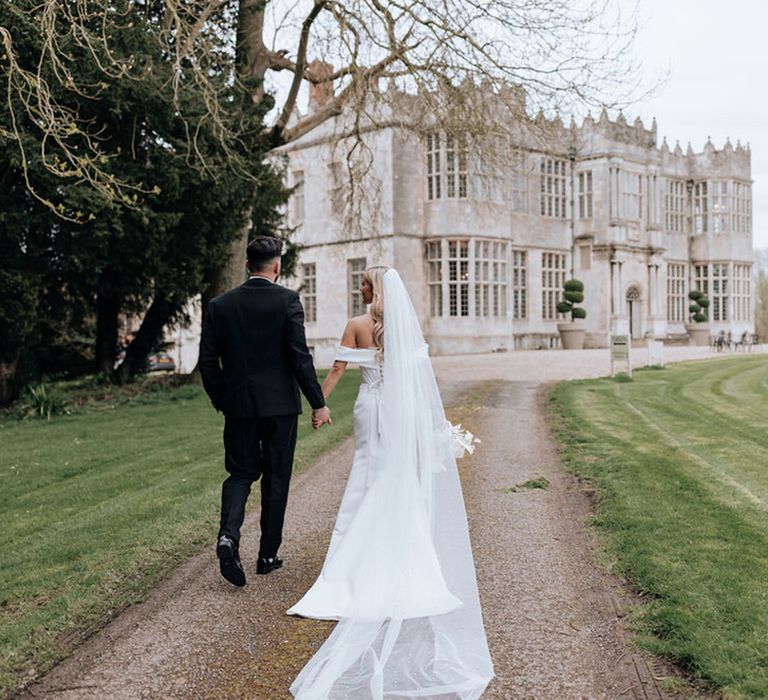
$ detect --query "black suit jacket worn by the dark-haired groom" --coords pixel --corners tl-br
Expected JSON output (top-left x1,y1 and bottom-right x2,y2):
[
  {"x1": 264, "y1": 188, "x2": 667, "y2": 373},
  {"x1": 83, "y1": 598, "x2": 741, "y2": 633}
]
[{"x1": 200, "y1": 277, "x2": 325, "y2": 418}]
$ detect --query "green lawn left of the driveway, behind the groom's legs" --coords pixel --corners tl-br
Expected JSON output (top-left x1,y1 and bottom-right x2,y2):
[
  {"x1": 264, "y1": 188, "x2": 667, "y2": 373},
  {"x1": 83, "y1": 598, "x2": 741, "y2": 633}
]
[{"x1": 0, "y1": 371, "x2": 359, "y2": 696}]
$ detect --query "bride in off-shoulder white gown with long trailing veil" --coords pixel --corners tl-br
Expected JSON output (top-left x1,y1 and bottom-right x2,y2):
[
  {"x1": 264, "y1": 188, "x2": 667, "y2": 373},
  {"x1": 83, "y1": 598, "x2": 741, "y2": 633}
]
[{"x1": 288, "y1": 266, "x2": 493, "y2": 700}]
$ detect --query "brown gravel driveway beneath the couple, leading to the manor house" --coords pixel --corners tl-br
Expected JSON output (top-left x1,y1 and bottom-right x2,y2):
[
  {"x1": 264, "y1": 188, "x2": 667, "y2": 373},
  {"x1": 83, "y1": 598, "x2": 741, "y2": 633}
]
[{"x1": 23, "y1": 348, "x2": 736, "y2": 700}]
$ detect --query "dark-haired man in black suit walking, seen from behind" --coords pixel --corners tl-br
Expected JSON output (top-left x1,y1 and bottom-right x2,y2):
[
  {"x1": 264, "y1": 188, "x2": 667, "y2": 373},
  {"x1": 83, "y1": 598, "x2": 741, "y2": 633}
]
[{"x1": 200, "y1": 236, "x2": 331, "y2": 586}]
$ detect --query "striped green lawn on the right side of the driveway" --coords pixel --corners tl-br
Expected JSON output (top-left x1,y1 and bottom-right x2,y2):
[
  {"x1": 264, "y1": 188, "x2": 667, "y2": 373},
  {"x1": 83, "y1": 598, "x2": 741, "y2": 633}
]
[{"x1": 550, "y1": 356, "x2": 768, "y2": 698}]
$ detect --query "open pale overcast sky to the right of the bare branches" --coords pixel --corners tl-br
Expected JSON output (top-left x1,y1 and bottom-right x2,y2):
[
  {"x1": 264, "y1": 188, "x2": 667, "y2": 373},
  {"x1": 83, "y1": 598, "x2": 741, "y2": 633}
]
[{"x1": 620, "y1": 0, "x2": 768, "y2": 247}]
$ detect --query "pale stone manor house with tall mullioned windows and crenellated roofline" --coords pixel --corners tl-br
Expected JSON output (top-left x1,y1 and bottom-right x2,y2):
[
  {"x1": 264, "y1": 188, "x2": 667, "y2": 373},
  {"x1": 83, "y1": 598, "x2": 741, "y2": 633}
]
[{"x1": 282, "y1": 94, "x2": 754, "y2": 366}]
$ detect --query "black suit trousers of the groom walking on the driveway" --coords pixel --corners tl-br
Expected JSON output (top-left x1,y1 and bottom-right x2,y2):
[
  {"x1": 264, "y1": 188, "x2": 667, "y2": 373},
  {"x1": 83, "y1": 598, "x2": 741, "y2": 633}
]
[{"x1": 219, "y1": 415, "x2": 298, "y2": 558}]
